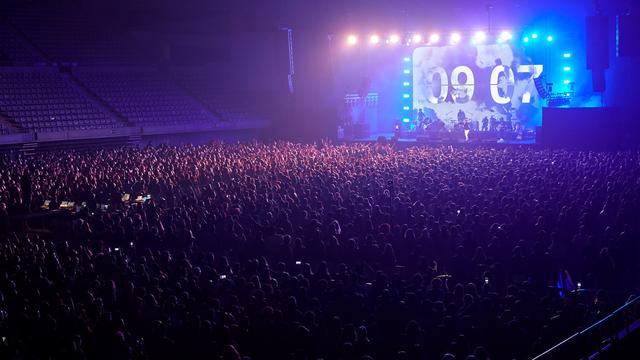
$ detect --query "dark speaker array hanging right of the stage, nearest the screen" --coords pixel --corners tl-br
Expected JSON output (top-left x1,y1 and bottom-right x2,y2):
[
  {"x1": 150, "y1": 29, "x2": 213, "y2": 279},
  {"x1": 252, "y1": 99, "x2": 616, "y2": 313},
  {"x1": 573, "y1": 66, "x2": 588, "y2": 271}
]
[{"x1": 586, "y1": 15, "x2": 609, "y2": 70}]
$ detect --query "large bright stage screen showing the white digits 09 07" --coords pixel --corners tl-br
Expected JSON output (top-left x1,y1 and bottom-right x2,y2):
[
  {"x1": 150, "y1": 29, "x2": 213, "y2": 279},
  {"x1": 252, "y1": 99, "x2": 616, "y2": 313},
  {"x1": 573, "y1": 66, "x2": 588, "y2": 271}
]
[{"x1": 412, "y1": 43, "x2": 544, "y2": 129}]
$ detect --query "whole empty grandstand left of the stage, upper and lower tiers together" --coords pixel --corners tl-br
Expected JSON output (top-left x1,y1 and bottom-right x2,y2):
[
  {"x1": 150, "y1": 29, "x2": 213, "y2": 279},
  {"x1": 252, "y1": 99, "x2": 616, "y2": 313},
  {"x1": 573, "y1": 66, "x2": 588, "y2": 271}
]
[{"x1": 0, "y1": 5, "x2": 255, "y2": 134}]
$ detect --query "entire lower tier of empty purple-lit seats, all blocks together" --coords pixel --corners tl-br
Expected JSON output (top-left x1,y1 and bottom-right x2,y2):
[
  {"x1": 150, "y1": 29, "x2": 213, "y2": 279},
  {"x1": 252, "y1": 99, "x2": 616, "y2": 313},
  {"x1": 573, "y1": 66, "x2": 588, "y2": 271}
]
[{"x1": 0, "y1": 68, "x2": 262, "y2": 132}]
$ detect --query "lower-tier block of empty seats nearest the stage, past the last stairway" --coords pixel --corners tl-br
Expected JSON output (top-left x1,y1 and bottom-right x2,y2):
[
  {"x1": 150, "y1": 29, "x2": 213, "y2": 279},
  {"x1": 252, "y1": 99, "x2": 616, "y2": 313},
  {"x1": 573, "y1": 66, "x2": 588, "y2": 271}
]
[{"x1": 174, "y1": 69, "x2": 256, "y2": 121}]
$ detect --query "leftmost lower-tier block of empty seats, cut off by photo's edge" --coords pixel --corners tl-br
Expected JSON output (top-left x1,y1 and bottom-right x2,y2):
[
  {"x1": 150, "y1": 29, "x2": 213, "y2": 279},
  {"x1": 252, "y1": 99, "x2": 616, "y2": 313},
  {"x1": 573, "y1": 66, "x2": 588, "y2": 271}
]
[{"x1": 0, "y1": 68, "x2": 119, "y2": 132}]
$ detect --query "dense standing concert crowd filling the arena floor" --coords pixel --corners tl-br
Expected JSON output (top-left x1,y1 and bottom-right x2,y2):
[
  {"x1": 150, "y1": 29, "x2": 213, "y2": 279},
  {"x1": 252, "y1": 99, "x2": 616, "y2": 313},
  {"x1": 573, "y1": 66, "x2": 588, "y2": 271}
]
[{"x1": 0, "y1": 143, "x2": 640, "y2": 360}]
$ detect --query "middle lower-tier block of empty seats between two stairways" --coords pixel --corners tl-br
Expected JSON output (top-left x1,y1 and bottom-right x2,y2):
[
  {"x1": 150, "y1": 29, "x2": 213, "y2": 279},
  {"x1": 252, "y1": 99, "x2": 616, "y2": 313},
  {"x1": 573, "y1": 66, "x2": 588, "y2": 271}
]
[{"x1": 74, "y1": 68, "x2": 217, "y2": 126}]
